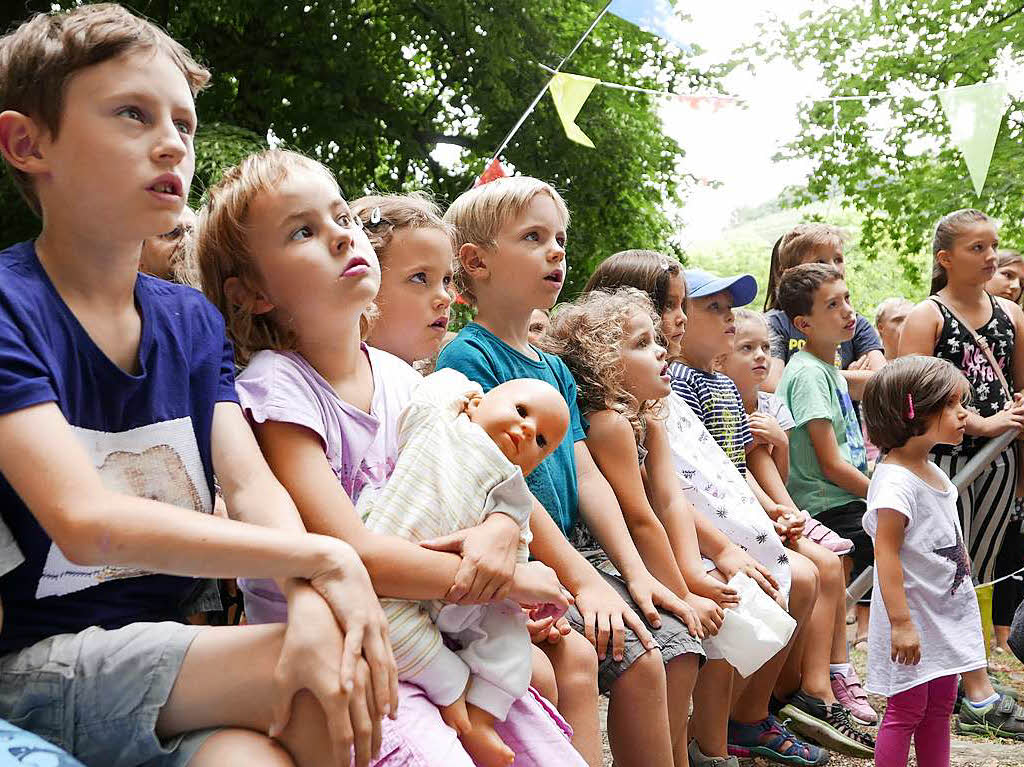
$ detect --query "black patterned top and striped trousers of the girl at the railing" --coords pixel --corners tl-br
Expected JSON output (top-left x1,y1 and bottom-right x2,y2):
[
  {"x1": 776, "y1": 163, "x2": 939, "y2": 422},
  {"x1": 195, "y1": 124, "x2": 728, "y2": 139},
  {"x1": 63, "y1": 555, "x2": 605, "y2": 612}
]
[{"x1": 932, "y1": 296, "x2": 1019, "y2": 583}]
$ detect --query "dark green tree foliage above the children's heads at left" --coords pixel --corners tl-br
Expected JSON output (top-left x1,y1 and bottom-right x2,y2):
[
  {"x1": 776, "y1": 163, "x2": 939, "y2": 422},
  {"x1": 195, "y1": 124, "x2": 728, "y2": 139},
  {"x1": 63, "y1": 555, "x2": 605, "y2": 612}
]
[{"x1": 0, "y1": 0, "x2": 714, "y2": 293}]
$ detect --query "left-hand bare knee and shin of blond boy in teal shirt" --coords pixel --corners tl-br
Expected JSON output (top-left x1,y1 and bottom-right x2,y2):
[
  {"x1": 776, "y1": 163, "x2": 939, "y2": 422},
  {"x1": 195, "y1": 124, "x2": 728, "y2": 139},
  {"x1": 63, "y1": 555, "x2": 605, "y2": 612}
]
[{"x1": 608, "y1": 649, "x2": 673, "y2": 767}]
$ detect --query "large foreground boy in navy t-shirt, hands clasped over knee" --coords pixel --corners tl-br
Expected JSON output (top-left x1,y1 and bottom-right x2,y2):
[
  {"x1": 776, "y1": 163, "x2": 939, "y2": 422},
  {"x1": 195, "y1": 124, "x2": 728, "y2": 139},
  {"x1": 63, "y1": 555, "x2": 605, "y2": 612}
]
[{"x1": 0, "y1": 5, "x2": 396, "y2": 767}]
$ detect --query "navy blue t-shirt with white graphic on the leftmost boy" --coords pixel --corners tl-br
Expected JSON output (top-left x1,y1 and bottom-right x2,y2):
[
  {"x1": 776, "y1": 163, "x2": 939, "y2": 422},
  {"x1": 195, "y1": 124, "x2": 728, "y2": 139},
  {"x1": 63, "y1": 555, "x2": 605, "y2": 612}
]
[{"x1": 0, "y1": 243, "x2": 238, "y2": 654}]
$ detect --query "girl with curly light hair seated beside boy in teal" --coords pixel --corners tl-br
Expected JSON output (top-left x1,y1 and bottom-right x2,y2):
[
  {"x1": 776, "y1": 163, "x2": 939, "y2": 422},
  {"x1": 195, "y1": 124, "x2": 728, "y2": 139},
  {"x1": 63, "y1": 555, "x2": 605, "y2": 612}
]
[{"x1": 545, "y1": 286, "x2": 824, "y2": 765}]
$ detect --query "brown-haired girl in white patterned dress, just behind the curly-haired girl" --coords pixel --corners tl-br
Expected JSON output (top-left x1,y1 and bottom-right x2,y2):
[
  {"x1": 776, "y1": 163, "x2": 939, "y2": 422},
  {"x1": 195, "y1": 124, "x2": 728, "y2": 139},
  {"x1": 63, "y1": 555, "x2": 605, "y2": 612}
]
[{"x1": 581, "y1": 250, "x2": 843, "y2": 765}]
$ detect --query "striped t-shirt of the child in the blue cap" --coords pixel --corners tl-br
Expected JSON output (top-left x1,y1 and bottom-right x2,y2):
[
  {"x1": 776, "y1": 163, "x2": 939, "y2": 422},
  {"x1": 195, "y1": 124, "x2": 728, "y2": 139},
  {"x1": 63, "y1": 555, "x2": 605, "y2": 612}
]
[{"x1": 669, "y1": 363, "x2": 754, "y2": 476}]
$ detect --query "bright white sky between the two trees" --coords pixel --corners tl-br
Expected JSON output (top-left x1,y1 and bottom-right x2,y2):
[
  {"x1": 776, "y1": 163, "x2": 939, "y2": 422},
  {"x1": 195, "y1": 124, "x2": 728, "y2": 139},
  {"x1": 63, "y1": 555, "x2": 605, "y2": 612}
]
[{"x1": 662, "y1": 0, "x2": 823, "y2": 246}]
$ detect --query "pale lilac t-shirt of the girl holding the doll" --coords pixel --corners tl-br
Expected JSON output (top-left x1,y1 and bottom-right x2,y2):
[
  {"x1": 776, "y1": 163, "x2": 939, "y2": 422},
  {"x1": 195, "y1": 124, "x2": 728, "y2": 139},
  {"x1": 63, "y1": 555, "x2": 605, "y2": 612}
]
[{"x1": 236, "y1": 344, "x2": 423, "y2": 623}]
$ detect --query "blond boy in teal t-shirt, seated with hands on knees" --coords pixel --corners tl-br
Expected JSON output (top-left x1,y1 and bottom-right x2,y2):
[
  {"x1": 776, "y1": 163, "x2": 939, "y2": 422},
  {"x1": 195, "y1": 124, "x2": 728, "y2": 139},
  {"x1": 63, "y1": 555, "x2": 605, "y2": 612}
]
[{"x1": 437, "y1": 176, "x2": 712, "y2": 767}]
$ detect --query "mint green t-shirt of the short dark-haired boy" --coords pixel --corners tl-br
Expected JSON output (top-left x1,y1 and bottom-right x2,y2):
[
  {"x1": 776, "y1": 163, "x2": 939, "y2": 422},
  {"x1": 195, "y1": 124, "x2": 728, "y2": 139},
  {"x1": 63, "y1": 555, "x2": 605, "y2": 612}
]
[{"x1": 775, "y1": 351, "x2": 867, "y2": 516}]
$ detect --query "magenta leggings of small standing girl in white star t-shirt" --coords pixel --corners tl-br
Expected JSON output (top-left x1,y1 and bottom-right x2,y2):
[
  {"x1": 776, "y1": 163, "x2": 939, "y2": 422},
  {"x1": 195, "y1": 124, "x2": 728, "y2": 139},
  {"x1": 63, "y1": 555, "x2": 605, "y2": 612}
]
[{"x1": 874, "y1": 674, "x2": 956, "y2": 767}]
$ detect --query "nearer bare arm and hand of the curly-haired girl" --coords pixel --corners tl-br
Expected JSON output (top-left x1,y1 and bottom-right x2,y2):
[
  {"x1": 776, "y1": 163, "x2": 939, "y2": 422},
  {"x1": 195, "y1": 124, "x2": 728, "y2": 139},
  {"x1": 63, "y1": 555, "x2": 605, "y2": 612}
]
[{"x1": 590, "y1": 411, "x2": 734, "y2": 638}]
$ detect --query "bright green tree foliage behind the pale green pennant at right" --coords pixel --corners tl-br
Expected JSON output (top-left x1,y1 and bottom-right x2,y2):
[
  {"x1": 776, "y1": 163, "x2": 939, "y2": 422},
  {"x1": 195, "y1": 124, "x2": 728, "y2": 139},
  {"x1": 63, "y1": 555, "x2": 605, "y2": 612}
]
[{"x1": 760, "y1": 0, "x2": 1024, "y2": 271}]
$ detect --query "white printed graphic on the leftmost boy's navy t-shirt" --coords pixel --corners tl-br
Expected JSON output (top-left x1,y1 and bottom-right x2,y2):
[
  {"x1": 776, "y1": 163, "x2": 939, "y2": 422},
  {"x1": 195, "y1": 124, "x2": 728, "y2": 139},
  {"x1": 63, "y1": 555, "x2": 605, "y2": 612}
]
[{"x1": 36, "y1": 417, "x2": 213, "y2": 599}]
